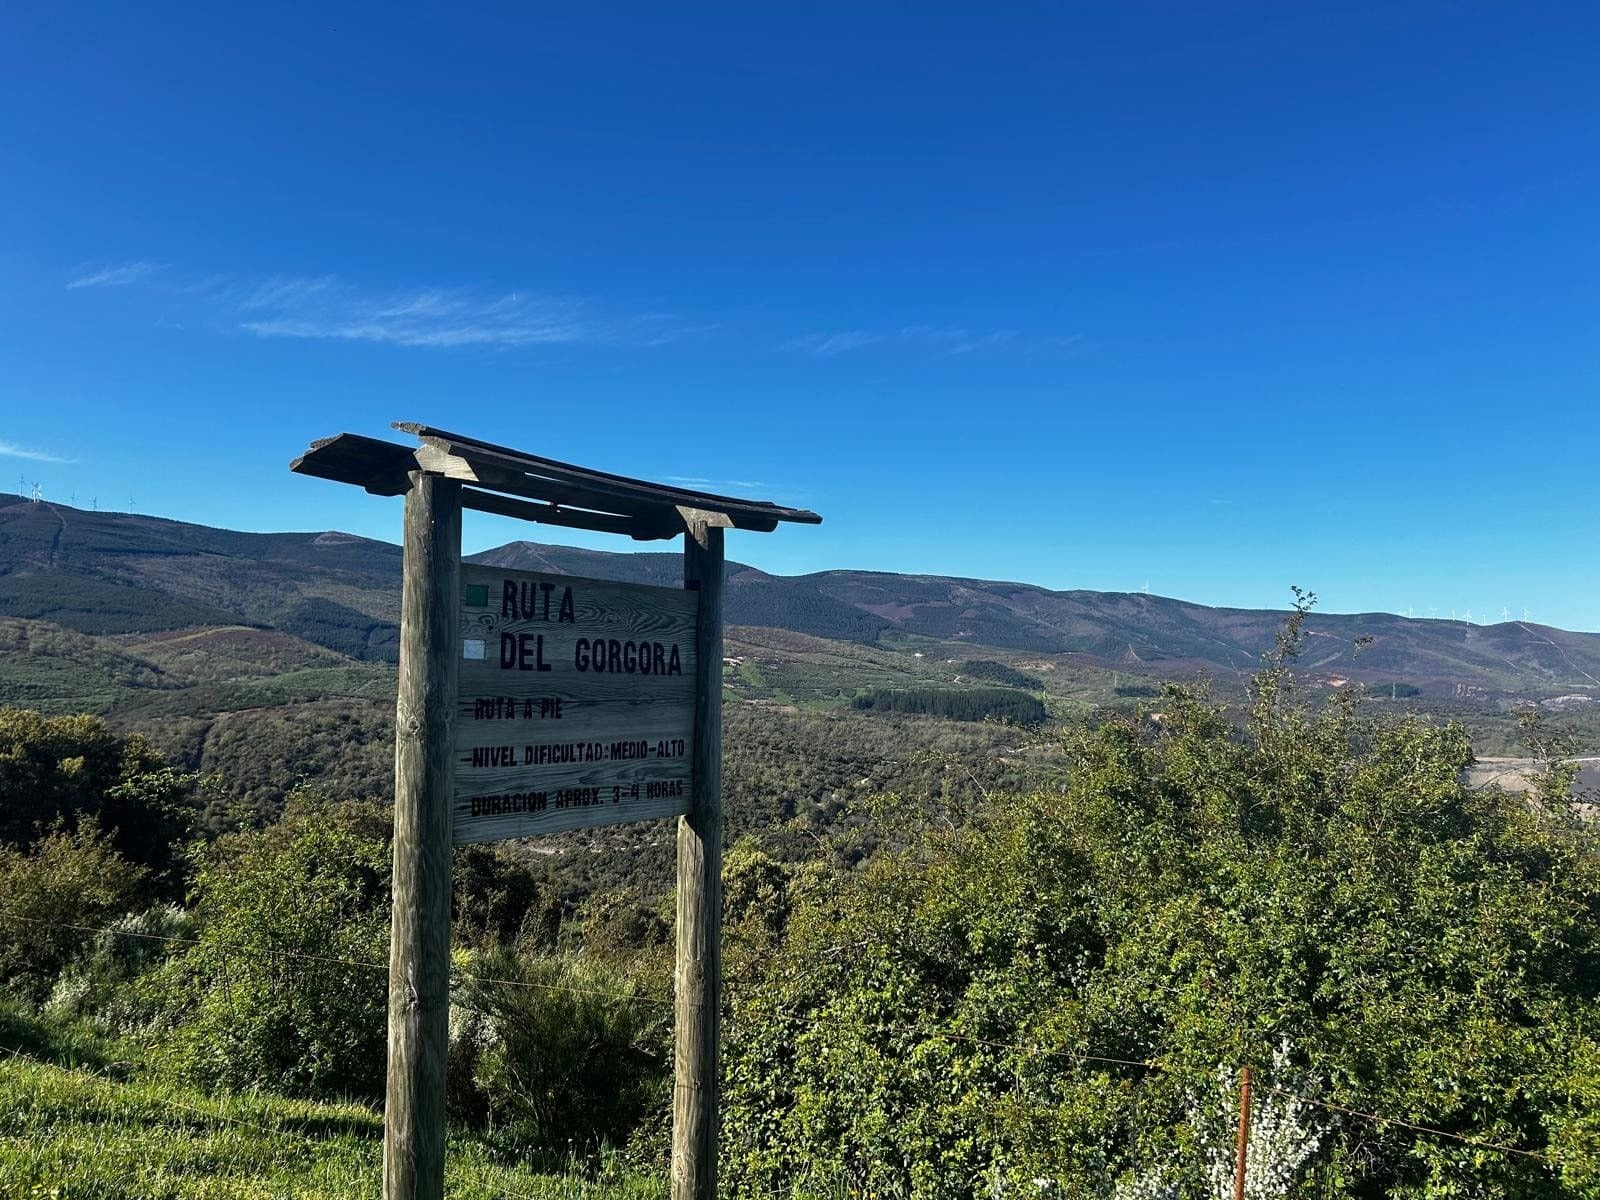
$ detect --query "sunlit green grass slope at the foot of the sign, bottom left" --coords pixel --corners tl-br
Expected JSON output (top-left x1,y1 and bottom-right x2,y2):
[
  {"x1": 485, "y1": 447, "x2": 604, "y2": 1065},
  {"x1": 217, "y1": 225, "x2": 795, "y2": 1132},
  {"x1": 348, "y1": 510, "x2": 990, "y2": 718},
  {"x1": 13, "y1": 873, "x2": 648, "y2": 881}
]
[{"x1": 0, "y1": 1054, "x2": 667, "y2": 1200}]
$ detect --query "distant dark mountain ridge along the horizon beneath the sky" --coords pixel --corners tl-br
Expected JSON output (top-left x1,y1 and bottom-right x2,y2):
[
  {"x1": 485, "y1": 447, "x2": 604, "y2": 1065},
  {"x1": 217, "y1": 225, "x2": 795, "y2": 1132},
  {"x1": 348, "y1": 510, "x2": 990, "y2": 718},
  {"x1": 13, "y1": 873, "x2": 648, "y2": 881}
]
[{"x1": 9, "y1": 499, "x2": 1600, "y2": 704}]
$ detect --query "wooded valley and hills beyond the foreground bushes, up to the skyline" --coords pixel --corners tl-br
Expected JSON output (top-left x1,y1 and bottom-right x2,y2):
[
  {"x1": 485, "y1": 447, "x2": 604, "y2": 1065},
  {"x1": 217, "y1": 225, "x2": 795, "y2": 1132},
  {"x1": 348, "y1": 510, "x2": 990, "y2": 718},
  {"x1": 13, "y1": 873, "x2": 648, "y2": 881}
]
[{"x1": 0, "y1": 501, "x2": 1600, "y2": 880}]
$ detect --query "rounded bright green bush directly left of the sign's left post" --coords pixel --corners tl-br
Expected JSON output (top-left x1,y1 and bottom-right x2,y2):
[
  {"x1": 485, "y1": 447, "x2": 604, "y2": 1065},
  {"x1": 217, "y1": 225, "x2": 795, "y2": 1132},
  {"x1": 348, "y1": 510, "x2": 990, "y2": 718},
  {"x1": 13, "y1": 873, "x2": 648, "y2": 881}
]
[{"x1": 162, "y1": 795, "x2": 390, "y2": 1098}]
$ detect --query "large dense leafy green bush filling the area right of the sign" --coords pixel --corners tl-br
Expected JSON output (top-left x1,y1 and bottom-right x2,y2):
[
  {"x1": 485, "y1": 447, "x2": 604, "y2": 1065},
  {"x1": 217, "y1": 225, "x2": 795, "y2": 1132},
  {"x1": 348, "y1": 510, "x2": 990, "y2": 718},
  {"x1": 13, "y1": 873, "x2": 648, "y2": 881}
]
[{"x1": 722, "y1": 611, "x2": 1600, "y2": 1200}]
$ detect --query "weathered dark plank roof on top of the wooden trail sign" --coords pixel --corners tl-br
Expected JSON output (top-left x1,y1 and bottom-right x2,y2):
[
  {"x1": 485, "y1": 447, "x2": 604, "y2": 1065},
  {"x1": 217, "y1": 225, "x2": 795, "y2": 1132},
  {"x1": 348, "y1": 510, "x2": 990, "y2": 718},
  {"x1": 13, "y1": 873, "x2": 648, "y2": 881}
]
[{"x1": 290, "y1": 421, "x2": 822, "y2": 541}]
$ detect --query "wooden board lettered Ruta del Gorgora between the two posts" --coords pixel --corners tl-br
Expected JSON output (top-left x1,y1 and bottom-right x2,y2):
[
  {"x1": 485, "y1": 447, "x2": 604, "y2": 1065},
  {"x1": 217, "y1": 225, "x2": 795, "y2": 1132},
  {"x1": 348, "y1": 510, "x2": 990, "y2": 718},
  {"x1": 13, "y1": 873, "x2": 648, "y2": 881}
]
[{"x1": 454, "y1": 563, "x2": 699, "y2": 845}]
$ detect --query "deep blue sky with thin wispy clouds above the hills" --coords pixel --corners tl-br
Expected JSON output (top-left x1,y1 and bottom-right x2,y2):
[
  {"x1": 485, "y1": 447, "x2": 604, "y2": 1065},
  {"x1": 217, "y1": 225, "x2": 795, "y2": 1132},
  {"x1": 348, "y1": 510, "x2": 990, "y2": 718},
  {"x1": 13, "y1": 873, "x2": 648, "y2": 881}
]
[{"x1": 0, "y1": 0, "x2": 1600, "y2": 629}]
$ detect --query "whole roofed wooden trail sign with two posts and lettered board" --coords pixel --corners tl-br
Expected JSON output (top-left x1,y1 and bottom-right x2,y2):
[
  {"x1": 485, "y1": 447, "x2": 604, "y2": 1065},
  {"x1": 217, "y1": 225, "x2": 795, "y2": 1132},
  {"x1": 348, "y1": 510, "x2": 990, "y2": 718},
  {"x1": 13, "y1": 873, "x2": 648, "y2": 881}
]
[{"x1": 291, "y1": 424, "x2": 821, "y2": 1200}]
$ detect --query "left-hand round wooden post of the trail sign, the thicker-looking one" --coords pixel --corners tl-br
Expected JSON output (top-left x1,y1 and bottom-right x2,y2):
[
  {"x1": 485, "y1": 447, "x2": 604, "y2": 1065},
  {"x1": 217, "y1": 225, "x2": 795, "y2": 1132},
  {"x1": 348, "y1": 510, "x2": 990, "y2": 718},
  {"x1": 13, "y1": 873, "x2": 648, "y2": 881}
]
[{"x1": 384, "y1": 472, "x2": 461, "y2": 1200}]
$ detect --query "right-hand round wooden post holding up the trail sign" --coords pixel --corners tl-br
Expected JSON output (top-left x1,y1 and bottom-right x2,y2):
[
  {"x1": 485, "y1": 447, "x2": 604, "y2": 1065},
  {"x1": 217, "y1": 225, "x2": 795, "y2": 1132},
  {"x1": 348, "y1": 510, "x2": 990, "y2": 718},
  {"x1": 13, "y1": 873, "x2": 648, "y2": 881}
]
[{"x1": 672, "y1": 512, "x2": 726, "y2": 1200}]
